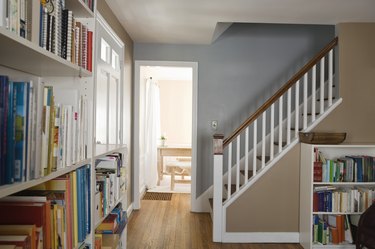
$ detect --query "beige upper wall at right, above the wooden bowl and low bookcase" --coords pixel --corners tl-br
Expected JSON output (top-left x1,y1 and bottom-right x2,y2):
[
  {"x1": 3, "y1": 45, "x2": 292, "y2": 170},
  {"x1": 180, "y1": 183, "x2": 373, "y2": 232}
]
[{"x1": 315, "y1": 23, "x2": 375, "y2": 143}]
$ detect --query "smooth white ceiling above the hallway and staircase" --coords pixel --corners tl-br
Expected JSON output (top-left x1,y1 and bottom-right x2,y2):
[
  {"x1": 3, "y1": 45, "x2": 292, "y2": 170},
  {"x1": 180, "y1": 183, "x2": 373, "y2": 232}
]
[{"x1": 106, "y1": 0, "x2": 375, "y2": 44}]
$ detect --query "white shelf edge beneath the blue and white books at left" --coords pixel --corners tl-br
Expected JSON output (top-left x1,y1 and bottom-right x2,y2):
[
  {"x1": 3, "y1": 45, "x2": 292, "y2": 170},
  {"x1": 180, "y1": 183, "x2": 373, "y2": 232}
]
[{"x1": 0, "y1": 159, "x2": 91, "y2": 198}]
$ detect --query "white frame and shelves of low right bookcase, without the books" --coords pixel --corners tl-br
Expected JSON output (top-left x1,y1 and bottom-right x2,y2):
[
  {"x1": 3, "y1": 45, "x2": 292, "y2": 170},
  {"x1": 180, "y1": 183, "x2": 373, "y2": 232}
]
[{"x1": 299, "y1": 143, "x2": 375, "y2": 249}]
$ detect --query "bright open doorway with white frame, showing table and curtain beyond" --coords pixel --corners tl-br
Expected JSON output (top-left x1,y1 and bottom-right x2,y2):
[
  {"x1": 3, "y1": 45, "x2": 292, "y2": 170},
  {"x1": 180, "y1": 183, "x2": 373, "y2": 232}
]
[{"x1": 133, "y1": 61, "x2": 198, "y2": 209}]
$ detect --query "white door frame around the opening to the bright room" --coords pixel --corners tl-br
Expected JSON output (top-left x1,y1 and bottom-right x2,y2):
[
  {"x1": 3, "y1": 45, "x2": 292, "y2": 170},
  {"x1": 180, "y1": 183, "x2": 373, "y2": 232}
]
[{"x1": 132, "y1": 60, "x2": 198, "y2": 210}]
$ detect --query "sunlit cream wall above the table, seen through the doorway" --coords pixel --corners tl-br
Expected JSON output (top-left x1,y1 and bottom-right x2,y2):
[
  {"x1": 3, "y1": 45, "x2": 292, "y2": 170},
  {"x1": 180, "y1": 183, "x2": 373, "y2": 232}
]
[{"x1": 158, "y1": 80, "x2": 193, "y2": 146}]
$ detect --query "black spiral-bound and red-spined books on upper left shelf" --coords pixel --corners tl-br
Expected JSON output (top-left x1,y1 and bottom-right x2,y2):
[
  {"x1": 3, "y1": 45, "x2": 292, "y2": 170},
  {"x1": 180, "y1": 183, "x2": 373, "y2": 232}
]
[{"x1": 39, "y1": 0, "x2": 93, "y2": 71}]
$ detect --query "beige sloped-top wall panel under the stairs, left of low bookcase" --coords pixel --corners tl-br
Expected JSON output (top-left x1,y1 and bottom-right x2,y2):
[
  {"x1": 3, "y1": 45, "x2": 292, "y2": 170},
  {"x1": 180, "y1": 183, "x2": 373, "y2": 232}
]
[{"x1": 227, "y1": 146, "x2": 299, "y2": 232}]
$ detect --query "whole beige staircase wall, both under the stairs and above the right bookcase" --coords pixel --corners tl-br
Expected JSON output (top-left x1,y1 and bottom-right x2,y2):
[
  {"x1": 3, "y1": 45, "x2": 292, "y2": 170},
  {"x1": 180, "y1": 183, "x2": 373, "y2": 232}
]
[{"x1": 227, "y1": 23, "x2": 375, "y2": 232}]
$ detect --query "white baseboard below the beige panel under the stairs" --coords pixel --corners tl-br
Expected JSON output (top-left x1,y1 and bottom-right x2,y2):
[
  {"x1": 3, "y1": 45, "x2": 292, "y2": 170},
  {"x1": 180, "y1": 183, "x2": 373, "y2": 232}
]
[{"x1": 222, "y1": 232, "x2": 299, "y2": 243}]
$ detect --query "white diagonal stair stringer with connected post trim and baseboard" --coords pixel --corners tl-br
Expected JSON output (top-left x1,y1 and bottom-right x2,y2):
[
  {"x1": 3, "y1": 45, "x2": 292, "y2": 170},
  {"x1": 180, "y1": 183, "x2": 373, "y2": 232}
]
[{"x1": 222, "y1": 98, "x2": 342, "y2": 243}]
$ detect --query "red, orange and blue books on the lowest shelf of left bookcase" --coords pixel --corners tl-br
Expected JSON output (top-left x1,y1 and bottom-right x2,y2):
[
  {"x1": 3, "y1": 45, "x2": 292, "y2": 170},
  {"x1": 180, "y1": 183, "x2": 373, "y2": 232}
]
[{"x1": 0, "y1": 165, "x2": 91, "y2": 249}]
